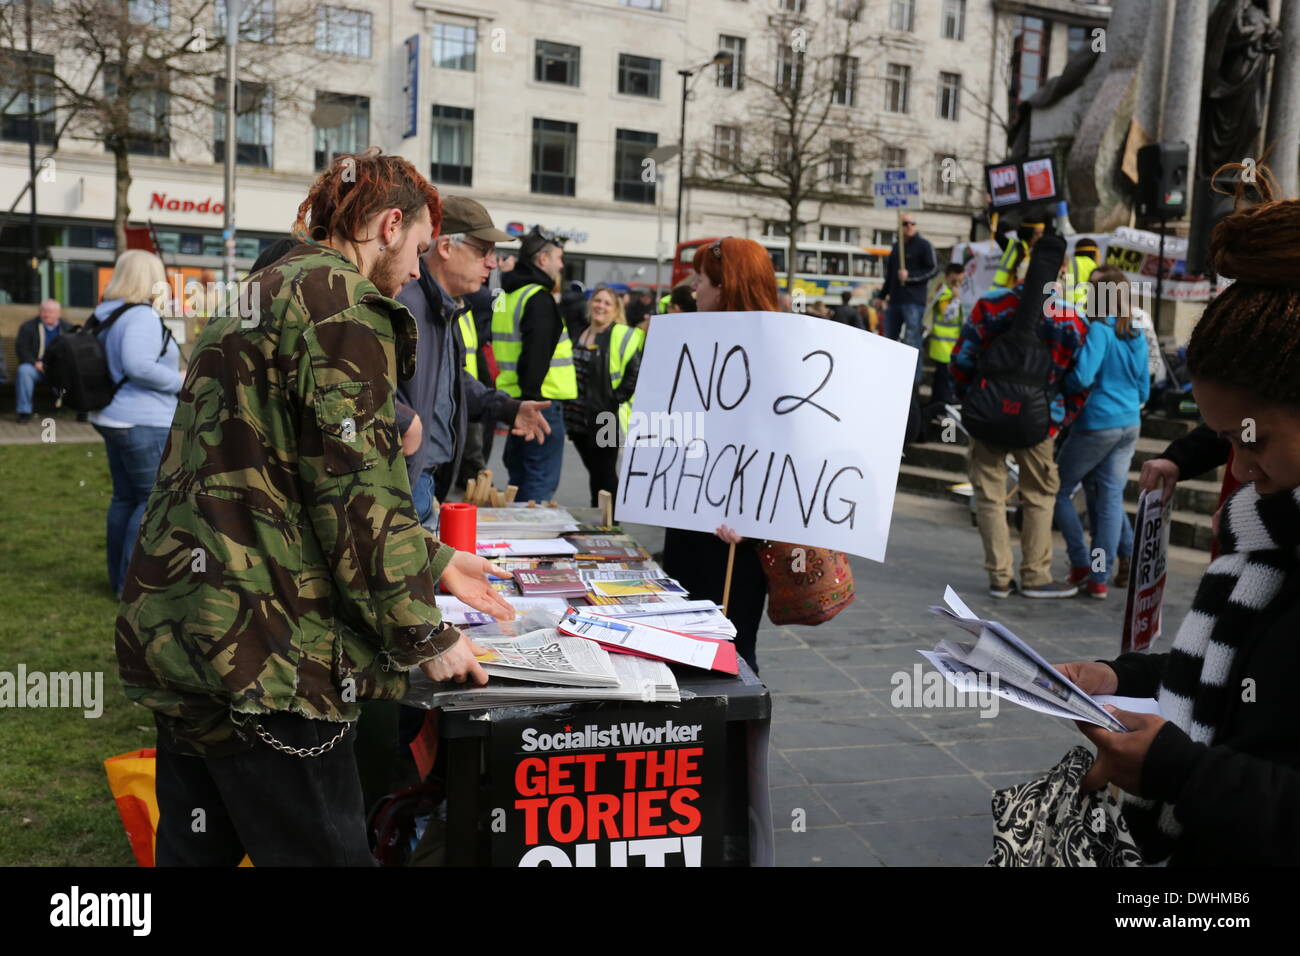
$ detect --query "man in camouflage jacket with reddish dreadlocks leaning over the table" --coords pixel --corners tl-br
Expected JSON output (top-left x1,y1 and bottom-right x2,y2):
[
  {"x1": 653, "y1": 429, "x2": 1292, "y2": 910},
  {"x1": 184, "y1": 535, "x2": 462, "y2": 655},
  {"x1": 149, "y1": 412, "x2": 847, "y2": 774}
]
[{"x1": 117, "y1": 155, "x2": 511, "y2": 865}]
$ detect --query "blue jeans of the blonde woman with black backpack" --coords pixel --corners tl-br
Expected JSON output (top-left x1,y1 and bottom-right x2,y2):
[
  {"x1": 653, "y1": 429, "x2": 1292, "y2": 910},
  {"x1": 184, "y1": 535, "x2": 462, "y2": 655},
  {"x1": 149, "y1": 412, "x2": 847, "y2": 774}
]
[{"x1": 95, "y1": 425, "x2": 170, "y2": 596}]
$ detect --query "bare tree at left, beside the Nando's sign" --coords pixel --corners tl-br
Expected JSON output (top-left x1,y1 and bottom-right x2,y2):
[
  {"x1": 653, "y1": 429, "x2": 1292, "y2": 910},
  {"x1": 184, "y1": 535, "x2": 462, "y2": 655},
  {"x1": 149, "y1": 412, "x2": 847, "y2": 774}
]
[{"x1": 0, "y1": 0, "x2": 340, "y2": 252}]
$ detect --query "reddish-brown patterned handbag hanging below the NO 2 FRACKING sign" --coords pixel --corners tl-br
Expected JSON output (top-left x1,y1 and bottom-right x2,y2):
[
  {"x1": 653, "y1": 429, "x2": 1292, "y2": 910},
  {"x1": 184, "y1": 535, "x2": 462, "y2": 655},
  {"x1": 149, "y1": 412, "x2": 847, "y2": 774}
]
[{"x1": 758, "y1": 541, "x2": 855, "y2": 624}]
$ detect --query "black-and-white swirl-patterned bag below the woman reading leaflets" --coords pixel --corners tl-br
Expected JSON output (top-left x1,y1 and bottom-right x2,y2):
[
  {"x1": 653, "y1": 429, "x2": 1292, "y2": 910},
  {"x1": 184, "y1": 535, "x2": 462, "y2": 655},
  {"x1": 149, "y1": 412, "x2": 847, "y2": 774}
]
[{"x1": 987, "y1": 747, "x2": 1143, "y2": 866}]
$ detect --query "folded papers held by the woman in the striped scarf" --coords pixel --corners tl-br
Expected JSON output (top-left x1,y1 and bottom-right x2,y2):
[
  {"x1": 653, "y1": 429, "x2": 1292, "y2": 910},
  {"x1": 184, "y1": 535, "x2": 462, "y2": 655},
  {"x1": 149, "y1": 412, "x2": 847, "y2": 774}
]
[{"x1": 925, "y1": 588, "x2": 1132, "y2": 732}]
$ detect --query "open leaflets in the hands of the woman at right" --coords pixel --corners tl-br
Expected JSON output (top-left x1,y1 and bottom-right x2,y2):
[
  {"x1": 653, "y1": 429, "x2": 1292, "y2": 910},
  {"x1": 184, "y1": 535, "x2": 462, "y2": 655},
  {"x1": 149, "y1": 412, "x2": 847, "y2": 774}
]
[{"x1": 930, "y1": 587, "x2": 1126, "y2": 731}]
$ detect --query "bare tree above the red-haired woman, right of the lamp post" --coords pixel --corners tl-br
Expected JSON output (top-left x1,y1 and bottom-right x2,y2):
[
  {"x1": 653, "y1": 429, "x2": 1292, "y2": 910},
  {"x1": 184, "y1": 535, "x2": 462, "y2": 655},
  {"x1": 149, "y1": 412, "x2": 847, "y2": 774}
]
[{"x1": 690, "y1": 0, "x2": 884, "y2": 289}]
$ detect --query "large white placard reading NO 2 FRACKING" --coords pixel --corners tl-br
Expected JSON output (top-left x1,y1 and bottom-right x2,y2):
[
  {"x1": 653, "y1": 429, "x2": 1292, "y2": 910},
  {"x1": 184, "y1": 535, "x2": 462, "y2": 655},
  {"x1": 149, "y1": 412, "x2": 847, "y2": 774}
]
[{"x1": 618, "y1": 312, "x2": 917, "y2": 561}]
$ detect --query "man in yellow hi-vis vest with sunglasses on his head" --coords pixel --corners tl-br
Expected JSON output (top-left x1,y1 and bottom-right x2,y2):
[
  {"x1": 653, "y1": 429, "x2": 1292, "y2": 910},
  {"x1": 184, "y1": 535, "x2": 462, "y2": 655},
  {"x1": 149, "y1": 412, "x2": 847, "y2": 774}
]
[{"x1": 491, "y1": 226, "x2": 577, "y2": 501}]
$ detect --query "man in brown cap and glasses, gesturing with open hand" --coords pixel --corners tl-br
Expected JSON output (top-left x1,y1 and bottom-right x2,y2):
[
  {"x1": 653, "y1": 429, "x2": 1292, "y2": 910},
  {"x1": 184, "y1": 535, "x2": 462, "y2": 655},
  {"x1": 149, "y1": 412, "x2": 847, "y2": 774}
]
[{"x1": 398, "y1": 196, "x2": 550, "y2": 524}]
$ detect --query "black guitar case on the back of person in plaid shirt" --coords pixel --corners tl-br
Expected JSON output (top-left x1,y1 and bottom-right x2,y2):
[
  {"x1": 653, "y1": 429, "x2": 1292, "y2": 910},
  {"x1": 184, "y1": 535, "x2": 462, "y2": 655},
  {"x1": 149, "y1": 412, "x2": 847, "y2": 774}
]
[{"x1": 962, "y1": 235, "x2": 1065, "y2": 449}]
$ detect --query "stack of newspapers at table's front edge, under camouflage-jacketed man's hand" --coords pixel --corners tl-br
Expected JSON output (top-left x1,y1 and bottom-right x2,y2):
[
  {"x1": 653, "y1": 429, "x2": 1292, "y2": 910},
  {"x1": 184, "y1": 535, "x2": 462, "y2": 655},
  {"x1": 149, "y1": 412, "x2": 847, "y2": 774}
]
[{"x1": 410, "y1": 628, "x2": 681, "y2": 710}]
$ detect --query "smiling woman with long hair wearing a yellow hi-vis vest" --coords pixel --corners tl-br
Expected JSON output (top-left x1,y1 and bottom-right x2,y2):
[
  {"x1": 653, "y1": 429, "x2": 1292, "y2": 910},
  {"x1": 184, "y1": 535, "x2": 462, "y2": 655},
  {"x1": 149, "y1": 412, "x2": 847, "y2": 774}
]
[{"x1": 564, "y1": 286, "x2": 645, "y2": 507}]
